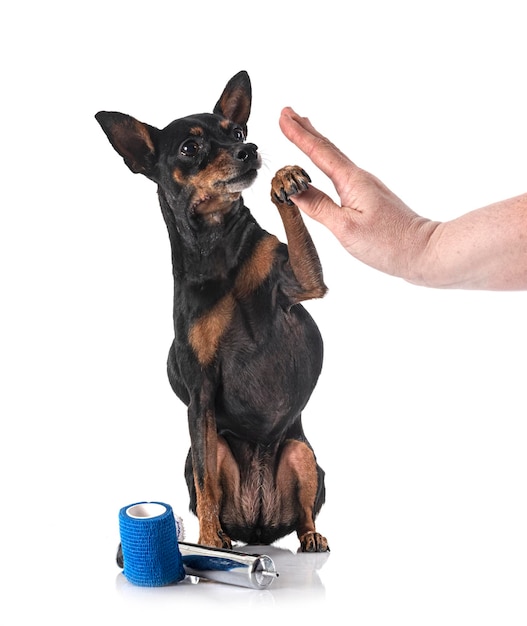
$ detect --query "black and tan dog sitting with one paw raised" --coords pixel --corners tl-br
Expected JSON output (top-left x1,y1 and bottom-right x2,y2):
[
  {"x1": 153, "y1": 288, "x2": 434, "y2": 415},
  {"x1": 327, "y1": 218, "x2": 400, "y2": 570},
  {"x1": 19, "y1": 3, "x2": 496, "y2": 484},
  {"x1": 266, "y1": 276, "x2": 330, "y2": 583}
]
[{"x1": 96, "y1": 72, "x2": 328, "y2": 552}]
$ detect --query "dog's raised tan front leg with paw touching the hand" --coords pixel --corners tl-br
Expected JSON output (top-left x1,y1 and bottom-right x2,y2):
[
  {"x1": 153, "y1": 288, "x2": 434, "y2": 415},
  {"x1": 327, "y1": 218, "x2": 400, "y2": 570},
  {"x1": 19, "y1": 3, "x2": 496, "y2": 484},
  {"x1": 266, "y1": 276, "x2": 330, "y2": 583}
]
[{"x1": 271, "y1": 165, "x2": 327, "y2": 302}]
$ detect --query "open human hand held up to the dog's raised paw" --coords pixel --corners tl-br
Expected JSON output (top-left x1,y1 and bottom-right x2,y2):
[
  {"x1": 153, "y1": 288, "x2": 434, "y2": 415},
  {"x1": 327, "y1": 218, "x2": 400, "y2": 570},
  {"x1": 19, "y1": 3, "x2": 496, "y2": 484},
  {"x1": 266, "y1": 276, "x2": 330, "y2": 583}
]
[{"x1": 279, "y1": 107, "x2": 437, "y2": 280}]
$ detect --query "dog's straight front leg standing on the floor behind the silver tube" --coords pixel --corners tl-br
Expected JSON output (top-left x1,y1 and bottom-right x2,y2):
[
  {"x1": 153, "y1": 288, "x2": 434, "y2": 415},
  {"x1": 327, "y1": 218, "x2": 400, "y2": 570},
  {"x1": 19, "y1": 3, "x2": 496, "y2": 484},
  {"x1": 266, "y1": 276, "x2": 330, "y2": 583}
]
[{"x1": 188, "y1": 382, "x2": 231, "y2": 548}]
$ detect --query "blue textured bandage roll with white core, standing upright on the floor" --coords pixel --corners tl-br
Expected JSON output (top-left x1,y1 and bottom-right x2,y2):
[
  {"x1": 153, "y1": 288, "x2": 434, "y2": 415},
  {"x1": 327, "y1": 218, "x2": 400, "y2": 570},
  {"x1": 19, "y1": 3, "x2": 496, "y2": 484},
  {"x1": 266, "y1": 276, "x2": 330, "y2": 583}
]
[{"x1": 119, "y1": 502, "x2": 185, "y2": 587}]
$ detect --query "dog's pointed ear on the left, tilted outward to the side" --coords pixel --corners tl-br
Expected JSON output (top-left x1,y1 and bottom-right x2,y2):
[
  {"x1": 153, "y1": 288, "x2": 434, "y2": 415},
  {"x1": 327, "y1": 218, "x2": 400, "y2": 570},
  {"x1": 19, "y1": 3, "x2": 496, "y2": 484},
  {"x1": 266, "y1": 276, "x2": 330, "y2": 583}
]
[{"x1": 95, "y1": 111, "x2": 159, "y2": 177}]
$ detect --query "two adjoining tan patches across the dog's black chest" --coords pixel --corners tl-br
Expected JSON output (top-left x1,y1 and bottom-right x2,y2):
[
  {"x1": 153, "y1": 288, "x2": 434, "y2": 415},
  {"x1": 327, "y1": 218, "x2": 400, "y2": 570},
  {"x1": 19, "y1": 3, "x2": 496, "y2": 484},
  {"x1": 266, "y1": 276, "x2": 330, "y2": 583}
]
[{"x1": 188, "y1": 235, "x2": 279, "y2": 367}]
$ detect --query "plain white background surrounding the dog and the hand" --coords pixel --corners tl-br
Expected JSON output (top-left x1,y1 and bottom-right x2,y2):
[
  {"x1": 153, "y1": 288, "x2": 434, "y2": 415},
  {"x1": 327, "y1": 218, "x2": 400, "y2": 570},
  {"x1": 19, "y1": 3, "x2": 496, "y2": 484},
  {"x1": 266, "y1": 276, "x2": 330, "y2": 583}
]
[{"x1": 0, "y1": 0, "x2": 527, "y2": 626}]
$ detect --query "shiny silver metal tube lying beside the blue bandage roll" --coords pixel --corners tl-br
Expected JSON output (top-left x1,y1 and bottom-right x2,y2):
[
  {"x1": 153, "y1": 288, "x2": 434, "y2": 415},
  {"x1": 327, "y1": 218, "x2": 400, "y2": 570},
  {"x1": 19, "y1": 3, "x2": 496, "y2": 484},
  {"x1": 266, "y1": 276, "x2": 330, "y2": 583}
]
[{"x1": 179, "y1": 541, "x2": 278, "y2": 589}]
